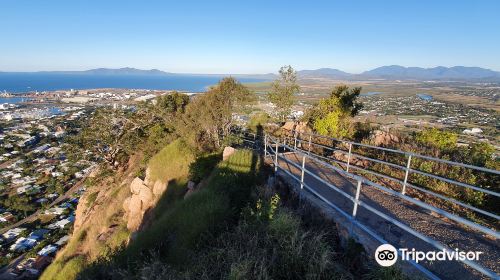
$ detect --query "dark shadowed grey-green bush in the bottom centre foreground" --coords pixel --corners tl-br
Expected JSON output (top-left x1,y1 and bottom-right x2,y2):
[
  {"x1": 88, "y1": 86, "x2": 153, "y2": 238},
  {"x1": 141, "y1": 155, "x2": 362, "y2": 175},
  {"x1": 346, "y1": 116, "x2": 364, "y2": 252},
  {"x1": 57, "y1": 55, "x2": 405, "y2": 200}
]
[{"x1": 178, "y1": 208, "x2": 341, "y2": 279}]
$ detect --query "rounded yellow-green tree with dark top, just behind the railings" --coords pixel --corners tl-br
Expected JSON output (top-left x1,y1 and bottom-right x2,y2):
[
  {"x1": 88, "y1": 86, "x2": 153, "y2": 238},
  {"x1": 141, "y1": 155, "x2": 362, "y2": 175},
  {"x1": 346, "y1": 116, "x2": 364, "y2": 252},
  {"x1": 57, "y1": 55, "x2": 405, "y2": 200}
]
[{"x1": 307, "y1": 85, "x2": 363, "y2": 138}]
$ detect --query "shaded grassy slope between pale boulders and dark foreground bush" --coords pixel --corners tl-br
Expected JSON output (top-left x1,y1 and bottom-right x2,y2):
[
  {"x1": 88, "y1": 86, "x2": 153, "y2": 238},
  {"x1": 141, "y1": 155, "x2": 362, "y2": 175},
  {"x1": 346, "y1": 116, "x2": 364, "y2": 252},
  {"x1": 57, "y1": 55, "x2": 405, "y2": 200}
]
[{"x1": 78, "y1": 151, "x2": 260, "y2": 279}]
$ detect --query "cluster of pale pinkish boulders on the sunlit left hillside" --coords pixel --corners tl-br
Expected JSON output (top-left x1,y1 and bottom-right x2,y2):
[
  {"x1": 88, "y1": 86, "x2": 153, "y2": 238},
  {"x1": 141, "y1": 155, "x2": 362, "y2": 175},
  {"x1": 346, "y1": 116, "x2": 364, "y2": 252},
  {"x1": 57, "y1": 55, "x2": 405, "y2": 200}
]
[{"x1": 123, "y1": 170, "x2": 167, "y2": 232}]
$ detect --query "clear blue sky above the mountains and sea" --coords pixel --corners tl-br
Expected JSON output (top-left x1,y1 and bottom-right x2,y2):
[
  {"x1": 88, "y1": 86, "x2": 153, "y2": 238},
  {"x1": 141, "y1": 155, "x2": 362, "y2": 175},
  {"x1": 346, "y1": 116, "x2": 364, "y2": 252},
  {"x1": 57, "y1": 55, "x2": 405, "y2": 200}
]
[{"x1": 0, "y1": 0, "x2": 500, "y2": 73}]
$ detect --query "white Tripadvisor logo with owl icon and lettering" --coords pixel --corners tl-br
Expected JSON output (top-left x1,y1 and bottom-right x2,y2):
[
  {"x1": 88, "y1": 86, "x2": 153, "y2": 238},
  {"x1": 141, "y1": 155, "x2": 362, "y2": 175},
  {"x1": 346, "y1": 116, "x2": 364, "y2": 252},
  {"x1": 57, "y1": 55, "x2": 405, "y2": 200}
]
[{"x1": 375, "y1": 244, "x2": 483, "y2": 266}]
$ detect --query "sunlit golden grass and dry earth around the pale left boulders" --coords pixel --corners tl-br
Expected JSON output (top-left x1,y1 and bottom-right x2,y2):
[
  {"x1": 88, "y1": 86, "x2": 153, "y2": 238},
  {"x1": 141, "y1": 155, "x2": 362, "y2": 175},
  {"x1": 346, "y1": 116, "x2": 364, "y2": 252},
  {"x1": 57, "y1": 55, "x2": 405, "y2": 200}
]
[{"x1": 41, "y1": 140, "x2": 195, "y2": 279}]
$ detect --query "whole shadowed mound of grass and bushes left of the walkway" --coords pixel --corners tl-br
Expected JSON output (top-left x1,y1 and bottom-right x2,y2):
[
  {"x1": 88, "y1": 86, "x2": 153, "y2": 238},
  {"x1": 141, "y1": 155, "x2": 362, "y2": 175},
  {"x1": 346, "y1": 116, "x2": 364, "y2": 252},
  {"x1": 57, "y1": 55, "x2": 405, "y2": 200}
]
[{"x1": 79, "y1": 150, "x2": 396, "y2": 279}]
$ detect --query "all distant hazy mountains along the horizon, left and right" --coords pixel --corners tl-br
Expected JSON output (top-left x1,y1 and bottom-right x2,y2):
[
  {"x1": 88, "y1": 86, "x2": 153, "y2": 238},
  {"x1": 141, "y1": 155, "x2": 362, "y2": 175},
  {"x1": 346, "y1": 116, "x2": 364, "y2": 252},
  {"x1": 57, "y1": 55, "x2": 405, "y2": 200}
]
[{"x1": 0, "y1": 65, "x2": 500, "y2": 82}]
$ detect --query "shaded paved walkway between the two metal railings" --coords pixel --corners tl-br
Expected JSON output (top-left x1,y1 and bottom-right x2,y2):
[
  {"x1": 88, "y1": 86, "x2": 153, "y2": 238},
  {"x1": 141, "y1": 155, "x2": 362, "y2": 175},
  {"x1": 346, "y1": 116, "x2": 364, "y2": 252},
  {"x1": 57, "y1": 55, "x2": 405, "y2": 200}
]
[{"x1": 267, "y1": 153, "x2": 500, "y2": 279}]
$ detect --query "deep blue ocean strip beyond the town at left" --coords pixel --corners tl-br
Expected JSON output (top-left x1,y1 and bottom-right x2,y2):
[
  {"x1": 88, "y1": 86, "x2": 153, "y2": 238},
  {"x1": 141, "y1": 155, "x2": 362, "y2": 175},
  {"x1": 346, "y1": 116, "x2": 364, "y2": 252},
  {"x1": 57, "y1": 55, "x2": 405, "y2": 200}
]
[{"x1": 0, "y1": 72, "x2": 263, "y2": 93}]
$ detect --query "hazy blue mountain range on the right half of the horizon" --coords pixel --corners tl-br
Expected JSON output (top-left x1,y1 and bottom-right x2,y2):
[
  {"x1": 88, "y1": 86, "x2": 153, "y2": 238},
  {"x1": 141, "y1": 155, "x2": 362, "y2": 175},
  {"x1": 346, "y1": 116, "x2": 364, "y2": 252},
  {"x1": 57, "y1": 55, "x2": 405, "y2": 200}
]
[{"x1": 297, "y1": 65, "x2": 500, "y2": 82}]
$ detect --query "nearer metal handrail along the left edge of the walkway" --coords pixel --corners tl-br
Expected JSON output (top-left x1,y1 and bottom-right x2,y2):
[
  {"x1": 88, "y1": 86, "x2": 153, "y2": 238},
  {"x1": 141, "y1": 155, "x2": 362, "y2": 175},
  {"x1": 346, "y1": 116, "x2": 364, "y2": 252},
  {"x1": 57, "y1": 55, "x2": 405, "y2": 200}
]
[{"x1": 264, "y1": 135, "x2": 500, "y2": 278}]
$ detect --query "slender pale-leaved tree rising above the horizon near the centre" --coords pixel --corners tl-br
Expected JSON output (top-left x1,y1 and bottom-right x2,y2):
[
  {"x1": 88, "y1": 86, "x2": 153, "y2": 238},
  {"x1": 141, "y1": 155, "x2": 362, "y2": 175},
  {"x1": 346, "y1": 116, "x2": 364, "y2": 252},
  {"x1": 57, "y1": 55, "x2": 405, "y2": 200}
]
[{"x1": 268, "y1": 65, "x2": 300, "y2": 122}]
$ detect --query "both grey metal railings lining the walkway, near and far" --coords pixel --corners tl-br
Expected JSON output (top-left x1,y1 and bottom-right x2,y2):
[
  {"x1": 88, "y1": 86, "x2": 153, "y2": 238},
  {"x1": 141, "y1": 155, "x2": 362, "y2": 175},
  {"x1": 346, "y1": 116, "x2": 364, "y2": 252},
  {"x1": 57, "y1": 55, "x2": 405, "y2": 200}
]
[{"x1": 244, "y1": 131, "x2": 500, "y2": 279}]
